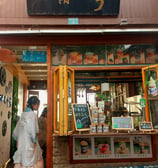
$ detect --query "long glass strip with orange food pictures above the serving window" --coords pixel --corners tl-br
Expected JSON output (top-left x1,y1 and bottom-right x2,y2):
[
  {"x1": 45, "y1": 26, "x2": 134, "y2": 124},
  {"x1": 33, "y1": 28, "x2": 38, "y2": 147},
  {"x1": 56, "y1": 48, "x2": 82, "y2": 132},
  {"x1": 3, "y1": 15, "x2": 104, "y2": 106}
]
[{"x1": 52, "y1": 44, "x2": 158, "y2": 66}]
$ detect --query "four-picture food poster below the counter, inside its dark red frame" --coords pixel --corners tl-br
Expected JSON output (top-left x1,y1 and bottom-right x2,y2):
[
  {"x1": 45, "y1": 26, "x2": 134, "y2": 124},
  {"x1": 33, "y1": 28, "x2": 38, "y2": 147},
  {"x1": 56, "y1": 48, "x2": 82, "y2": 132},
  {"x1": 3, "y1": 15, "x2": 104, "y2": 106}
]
[{"x1": 73, "y1": 135, "x2": 152, "y2": 160}]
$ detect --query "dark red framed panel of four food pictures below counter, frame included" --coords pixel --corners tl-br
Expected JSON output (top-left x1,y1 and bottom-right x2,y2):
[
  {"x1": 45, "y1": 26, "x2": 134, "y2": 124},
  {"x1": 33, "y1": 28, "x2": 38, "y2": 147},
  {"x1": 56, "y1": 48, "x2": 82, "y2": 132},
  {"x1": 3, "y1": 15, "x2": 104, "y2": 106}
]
[{"x1": 69, "y1": 134, "x2": 156, "y2": 163}]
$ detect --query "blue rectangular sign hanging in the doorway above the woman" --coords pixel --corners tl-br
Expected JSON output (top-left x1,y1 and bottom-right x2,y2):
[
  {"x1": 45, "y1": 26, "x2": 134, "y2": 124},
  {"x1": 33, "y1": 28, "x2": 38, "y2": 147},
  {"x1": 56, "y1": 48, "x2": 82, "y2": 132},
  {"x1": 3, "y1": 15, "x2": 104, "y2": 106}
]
[{"x1": 22, "y1": 50, "x2": 47, "y2": 62}]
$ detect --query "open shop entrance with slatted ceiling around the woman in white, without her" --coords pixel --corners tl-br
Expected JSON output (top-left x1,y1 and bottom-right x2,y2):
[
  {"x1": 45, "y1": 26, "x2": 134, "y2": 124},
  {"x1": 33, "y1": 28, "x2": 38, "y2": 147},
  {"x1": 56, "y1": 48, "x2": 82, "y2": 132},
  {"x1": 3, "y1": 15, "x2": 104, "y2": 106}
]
[{"x1": 0, "y1": 45, "x2": 47, "y2": 167}]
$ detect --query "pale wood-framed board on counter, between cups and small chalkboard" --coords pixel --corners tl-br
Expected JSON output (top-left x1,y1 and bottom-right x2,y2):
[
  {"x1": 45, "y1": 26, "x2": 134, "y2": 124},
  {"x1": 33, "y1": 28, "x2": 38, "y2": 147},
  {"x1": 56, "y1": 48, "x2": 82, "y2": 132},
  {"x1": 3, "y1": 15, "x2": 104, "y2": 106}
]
[{"x1": 112, "y1": 117, "x2": 134, "y2": 130}]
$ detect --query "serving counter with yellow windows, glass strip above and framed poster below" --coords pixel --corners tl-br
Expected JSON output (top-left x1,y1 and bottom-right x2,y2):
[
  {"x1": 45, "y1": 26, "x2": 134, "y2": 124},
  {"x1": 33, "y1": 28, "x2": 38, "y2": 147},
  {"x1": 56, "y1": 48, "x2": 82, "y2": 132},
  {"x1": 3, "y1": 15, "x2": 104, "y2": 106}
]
[{"x1": 52, "y1": 45, "x2": 158, "y2": 163}]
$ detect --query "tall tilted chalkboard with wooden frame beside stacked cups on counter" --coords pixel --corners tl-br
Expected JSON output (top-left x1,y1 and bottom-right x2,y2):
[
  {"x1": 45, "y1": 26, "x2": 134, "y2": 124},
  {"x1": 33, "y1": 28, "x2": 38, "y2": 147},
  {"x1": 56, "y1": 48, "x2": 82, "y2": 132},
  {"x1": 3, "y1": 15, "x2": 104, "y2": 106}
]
[{"x1": 72, "y1": 103, "x2": 91, "y2": 131}]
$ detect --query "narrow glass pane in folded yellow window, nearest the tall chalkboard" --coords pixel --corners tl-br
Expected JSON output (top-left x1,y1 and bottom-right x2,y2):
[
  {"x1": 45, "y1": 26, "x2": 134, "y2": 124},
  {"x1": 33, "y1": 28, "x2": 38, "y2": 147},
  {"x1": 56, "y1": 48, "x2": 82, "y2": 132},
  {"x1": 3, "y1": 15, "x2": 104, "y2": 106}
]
[{"x1": 68, "y1": 70, "x2": 73, "y2": 131}]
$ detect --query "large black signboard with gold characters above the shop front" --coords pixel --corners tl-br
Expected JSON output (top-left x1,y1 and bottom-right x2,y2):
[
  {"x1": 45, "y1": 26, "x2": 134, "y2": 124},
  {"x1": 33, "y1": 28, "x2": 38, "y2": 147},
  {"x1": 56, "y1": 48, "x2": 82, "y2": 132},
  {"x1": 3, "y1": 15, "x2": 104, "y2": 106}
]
[{"x1": 27, "y1": 0, "x2": 120, "y2": 16}]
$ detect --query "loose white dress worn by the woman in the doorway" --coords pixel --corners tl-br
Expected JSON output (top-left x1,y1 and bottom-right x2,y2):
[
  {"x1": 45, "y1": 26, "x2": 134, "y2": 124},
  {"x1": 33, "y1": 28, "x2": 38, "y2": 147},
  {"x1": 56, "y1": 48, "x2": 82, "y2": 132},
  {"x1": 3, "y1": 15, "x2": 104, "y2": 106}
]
[{"x1": 13, "y1": 107, "x2": 43, "y2": 168}]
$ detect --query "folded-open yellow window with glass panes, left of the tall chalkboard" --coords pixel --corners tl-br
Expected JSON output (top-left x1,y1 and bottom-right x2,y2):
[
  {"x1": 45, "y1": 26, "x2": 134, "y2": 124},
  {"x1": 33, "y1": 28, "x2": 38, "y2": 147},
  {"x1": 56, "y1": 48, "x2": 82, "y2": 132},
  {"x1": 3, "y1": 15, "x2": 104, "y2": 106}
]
[{"x1": 54, "y1": 65, "x2": 74, "y2": 136}]
